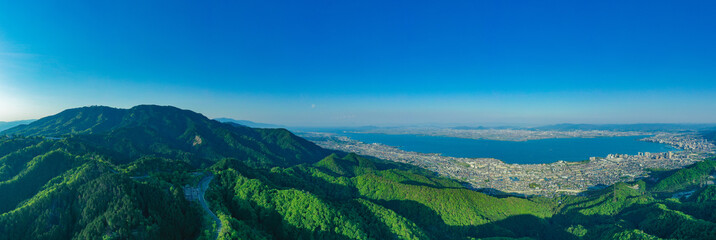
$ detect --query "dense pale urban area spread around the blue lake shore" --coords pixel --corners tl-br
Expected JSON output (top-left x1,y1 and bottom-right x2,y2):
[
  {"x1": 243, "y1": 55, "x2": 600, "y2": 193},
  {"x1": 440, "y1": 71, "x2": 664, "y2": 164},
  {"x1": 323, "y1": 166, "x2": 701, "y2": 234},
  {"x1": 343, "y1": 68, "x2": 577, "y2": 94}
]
[{"x1": 302, "y1": 129, "x2": 716, "y2": 196}]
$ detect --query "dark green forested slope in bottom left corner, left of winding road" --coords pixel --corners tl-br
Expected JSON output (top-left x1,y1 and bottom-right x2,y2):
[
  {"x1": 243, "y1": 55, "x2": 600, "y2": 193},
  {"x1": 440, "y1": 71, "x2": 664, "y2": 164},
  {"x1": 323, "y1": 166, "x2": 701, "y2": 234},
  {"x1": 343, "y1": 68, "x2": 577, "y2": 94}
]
[{"x1": 0, "y1": 157, "x2": 201, "y2": 240}]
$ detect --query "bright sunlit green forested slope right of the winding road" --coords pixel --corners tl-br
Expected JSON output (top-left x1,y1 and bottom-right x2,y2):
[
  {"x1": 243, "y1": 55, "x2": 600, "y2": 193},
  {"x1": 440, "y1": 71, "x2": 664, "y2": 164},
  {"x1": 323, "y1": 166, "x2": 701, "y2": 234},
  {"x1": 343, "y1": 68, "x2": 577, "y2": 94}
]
[{"x1": 207, "y1": 154, "x2": 569, "y2": 239}]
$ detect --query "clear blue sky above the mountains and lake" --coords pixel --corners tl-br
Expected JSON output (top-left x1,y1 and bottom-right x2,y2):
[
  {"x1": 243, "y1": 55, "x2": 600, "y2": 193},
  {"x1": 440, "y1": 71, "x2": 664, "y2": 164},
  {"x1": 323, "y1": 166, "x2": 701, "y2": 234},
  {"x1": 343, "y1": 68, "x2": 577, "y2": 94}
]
[{"x1": 0, "y1": 0, "x2": 716, "y2": 126}]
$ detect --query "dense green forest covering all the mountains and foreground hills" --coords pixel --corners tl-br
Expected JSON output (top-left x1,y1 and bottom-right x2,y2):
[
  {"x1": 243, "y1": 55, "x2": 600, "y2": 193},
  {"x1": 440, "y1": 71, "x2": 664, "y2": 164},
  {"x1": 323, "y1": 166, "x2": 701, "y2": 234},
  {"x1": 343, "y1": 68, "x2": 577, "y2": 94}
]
[{"x1": 0, "y1": 106, "x2": 716, "y2": 240}]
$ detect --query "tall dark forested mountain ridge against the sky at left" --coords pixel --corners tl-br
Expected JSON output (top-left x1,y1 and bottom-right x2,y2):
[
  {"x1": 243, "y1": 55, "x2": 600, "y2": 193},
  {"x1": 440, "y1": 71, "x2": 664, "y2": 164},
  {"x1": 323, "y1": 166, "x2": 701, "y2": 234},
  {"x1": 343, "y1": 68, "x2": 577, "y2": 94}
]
[{"x1": 0, "y1": 105, "x2": 329, "y2": 167}]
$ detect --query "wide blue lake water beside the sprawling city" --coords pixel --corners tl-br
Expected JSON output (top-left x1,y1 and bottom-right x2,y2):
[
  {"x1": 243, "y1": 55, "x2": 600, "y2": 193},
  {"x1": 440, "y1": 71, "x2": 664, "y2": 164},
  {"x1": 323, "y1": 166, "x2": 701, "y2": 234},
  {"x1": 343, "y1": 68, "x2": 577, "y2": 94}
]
[{"x1": 341, "y1": 133, "x2": 679, "y2": 164}]
